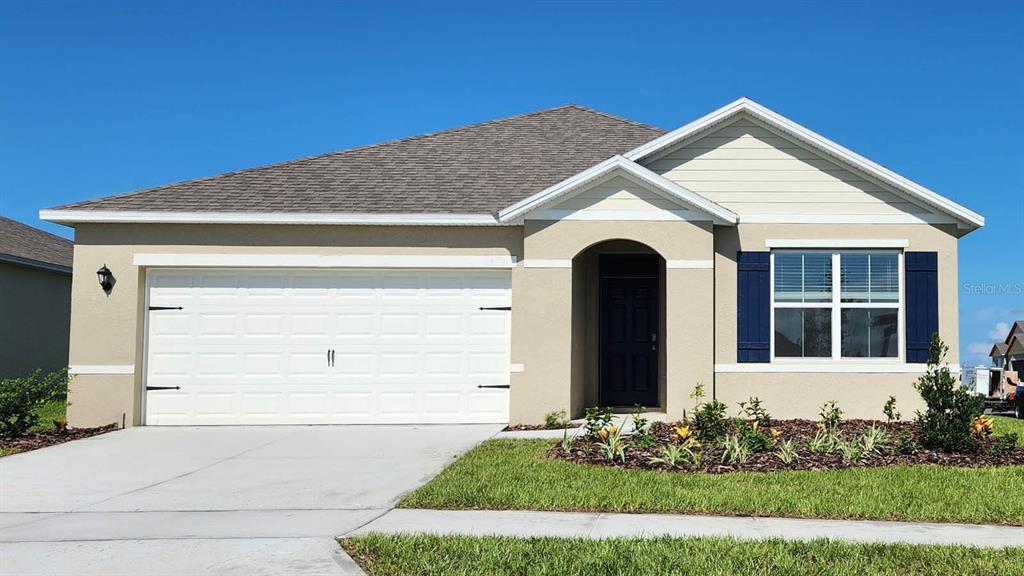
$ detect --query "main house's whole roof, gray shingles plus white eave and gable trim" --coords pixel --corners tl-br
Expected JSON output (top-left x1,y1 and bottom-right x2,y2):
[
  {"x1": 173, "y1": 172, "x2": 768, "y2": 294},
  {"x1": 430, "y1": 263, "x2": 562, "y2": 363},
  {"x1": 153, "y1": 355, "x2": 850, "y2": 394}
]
[{"x1": 40, "y1": 98, "x2": 984, "y2": 233}]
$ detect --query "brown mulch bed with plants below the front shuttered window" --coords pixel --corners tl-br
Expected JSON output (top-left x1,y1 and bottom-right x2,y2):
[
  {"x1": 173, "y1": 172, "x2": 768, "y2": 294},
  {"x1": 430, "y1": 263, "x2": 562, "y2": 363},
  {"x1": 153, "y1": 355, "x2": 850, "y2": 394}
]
[{"x1": 548, "y1": 420, "x2": 1024, "y2": 474}]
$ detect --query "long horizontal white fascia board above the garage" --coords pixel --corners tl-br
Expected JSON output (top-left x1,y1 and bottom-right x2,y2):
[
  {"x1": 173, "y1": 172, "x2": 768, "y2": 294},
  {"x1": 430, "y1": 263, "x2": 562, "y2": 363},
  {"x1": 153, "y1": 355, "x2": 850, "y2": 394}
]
[{"x1": 39, "y1": 209, "x2": 504, "y2": 225}]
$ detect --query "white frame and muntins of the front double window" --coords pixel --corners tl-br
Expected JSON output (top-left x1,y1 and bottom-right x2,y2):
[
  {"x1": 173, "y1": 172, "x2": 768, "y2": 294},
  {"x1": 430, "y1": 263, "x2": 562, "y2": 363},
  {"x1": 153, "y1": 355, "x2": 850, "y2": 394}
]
[{"x1": 768, "y1": 247, "x2": 906, "y2": 366}]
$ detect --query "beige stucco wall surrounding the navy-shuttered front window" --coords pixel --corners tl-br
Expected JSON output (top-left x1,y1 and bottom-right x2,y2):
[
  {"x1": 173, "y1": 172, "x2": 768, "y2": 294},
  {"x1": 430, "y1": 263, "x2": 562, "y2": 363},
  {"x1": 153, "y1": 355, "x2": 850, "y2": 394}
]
[{"x1": 715, "y1": 223, "x2": 959, "y2": 418}]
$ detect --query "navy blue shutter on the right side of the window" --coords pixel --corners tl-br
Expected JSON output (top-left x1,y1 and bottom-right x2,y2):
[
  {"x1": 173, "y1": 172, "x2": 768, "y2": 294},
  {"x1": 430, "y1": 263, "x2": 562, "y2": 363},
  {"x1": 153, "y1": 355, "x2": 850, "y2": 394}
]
[{"x1": 903, "y1": 252, "x2": 939, "y2": 363}]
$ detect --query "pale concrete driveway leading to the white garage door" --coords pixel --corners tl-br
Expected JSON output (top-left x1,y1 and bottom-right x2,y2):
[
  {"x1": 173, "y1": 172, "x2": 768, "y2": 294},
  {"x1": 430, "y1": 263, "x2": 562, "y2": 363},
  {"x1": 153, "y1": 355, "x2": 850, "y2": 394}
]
[{"x1": 0, "y1": 425, "x2": 501, "y2": 575}]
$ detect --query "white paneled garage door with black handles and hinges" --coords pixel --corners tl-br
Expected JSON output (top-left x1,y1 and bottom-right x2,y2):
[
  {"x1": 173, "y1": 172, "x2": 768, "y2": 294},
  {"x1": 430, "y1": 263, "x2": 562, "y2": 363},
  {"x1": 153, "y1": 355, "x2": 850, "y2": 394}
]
[{"x1": 145, "y1": 270, "x2": 511, "y2": 424}]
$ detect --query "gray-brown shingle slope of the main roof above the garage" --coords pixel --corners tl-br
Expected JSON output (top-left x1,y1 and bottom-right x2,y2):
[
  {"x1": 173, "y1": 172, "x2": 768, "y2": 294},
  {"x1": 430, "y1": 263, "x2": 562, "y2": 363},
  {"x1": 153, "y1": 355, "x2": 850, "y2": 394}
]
[{"x1": 57, "y1": 105, "x2": 664, "y2": 213}]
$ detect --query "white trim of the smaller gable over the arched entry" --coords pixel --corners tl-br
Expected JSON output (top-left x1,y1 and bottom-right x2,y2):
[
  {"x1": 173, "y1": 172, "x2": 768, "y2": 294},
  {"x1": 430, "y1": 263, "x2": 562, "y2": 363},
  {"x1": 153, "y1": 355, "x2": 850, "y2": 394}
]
[{"x1": 498, "y1": 156, "x2": 738, "y2": 224}]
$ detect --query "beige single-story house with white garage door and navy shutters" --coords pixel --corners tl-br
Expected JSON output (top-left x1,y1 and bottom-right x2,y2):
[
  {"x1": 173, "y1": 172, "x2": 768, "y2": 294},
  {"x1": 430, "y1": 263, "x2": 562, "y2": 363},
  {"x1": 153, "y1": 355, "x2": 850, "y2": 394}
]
[{"x1": 41, "y1": 98, "x2": 984, "y2": 425}]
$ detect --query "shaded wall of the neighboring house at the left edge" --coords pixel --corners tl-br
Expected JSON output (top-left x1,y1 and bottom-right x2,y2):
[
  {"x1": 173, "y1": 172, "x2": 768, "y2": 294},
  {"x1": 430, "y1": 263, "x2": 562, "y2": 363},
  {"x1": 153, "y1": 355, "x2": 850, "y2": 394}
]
[{"x1": 0, "y1": 262, "x2": 71, "y2": 378}]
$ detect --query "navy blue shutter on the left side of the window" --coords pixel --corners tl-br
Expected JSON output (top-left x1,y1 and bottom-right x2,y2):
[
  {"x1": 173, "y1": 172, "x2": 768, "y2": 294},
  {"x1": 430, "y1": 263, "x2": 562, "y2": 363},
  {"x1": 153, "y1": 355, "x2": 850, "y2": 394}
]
[{"x1": 736, "y1": 252, "x2": 771, "y2": 362}]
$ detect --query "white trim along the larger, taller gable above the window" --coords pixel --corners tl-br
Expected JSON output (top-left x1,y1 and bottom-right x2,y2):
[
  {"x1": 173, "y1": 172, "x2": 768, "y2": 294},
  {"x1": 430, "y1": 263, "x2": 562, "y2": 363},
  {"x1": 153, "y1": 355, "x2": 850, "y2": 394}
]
[{"x1": 624, "y1": 97, "x2": 985, "y2": 229}]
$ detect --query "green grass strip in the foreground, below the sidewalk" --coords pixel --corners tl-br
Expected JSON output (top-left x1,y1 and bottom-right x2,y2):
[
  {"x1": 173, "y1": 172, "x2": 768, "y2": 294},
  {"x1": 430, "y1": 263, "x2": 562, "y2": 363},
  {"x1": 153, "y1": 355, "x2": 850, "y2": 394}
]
[{"x1": 342, "y1": 534, "x2": 1024, "y2": 576}]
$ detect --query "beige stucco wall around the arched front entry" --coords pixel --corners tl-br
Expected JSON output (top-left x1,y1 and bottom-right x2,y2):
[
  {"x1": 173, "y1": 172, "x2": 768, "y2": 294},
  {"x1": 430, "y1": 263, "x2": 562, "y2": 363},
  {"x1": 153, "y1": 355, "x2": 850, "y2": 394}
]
[{"x1": 510, "y1": 220, "x2": 714, "y2": 423}]
